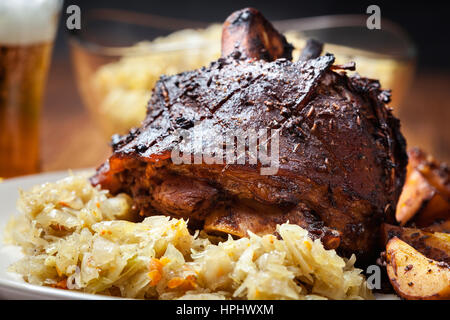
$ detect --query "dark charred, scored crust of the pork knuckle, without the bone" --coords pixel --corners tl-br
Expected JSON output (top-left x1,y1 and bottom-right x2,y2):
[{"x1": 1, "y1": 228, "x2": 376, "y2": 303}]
[{"x1": 92, "y1": 55, "x2": 407, "y2": 260}]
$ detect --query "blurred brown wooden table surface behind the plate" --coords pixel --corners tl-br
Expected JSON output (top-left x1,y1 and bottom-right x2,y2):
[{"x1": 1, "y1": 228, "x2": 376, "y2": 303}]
[{"x1": 41, "y1": 59, "x2": 450, "y2": 171}]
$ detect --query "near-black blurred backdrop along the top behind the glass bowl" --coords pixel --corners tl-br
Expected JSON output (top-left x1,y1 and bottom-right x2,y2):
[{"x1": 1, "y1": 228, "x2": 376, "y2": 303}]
[{"x1": 58, "y1": 0, "x2": 450, "y2": 71}]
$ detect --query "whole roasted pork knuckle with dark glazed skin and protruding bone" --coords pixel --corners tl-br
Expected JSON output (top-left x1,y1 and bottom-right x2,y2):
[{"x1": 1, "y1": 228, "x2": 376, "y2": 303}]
[{"x1": 92, "y1": 9, "x2": 407, "y2": 256}]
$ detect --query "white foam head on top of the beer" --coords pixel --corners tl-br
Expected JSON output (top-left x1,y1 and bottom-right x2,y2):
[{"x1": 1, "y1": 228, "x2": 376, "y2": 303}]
[{"x1": 0, "y1": 0, "x2": 62, "y2": 45}]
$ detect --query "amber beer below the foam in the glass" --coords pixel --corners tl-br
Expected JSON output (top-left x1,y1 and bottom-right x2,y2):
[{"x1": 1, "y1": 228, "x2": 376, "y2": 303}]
[{"x1": 0, "y1": 43, "x2": 52, "y2": 177}]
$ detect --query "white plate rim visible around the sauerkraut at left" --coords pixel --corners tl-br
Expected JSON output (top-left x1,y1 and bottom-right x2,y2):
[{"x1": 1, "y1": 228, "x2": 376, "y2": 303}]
[{"x1": 0, "y1": 170, "x2": 398, "y2": 300}]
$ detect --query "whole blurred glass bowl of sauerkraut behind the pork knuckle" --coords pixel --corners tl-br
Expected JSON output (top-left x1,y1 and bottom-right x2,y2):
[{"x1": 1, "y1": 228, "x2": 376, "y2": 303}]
[{"x1": 69, "y1": 9, "x2": 415, "y2": 138}]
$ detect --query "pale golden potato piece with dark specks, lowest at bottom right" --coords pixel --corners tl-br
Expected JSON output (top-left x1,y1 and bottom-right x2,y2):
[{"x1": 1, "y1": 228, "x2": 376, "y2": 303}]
[{"x1": 386, "y1": 238, "x2": 450, "y2": 300}]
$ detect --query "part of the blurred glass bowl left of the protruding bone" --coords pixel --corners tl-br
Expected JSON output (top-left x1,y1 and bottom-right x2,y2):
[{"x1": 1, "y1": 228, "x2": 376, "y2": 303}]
[{"x1": 69, "y1": 9, "x2": 221, "y2": 137}]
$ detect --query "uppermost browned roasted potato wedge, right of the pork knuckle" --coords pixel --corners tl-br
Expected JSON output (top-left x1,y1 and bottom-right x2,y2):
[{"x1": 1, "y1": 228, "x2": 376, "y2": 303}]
[{"x1": 396, "y1": 149, "x2": 450, "y2": 227}]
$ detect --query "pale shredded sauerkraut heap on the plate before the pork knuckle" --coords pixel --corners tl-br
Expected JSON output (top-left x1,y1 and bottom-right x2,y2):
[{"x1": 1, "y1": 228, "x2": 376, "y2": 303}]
[{"x1": 6, "y1": 175, "x2": 372, "y2": 299}]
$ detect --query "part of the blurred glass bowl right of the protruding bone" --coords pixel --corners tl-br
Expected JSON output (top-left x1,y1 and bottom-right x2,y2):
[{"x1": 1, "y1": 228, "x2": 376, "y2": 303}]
[{"x1": 274, "y1": 15, "x2": 417, "y2": 112}]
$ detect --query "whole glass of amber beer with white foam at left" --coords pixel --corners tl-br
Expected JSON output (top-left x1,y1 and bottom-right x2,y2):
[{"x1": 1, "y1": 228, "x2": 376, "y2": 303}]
[{"x1": 0, "y1": 0, "x2": 62, "y2": 178}]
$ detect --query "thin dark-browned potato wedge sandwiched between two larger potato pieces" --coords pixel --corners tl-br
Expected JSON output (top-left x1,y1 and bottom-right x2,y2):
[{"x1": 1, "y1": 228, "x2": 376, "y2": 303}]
[{"x1": 381, "y1": 224, "x2": 450, "y2": 264}]
